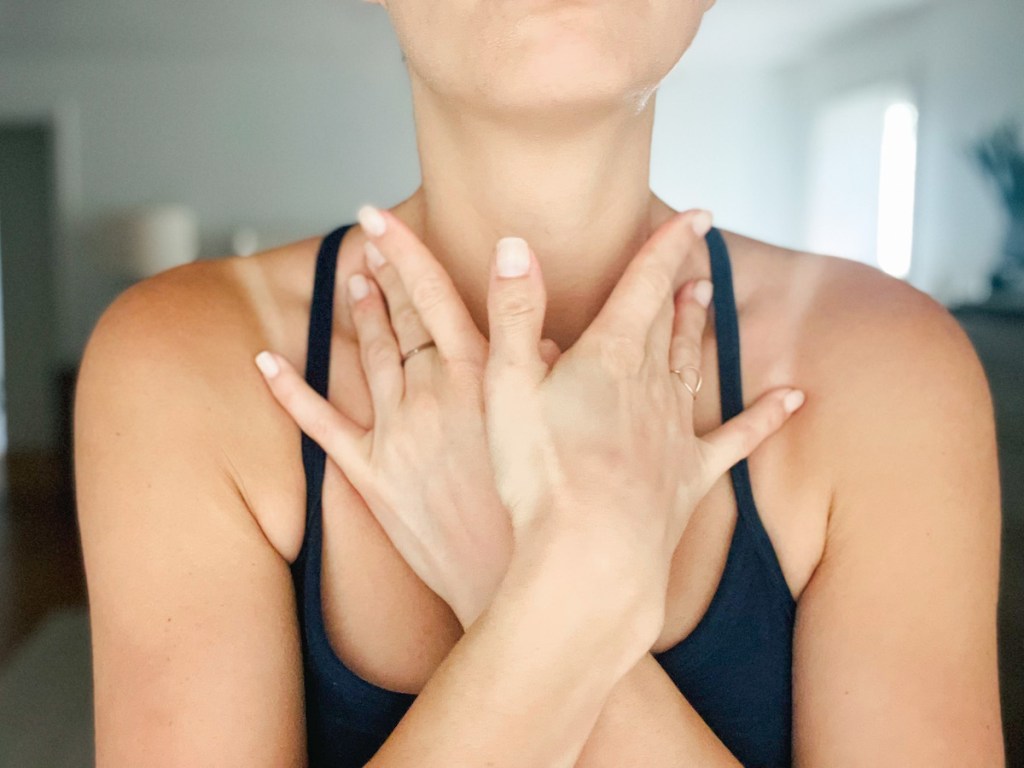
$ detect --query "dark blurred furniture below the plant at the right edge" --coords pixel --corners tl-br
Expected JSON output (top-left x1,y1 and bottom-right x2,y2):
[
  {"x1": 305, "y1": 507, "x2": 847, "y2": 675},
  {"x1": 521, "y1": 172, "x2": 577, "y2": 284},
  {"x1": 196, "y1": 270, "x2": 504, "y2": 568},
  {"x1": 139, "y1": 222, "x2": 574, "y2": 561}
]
[{"x1": 950, "y1": 295, "x2": 1024, "y2": 768}]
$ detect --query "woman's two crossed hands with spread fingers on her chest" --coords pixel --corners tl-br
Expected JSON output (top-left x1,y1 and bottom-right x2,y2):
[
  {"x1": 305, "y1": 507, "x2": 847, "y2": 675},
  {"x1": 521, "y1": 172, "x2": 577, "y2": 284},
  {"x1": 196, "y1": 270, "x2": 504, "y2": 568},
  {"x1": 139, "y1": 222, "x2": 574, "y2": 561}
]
[{"x1": 257, "y1": 205, "x2": 803, "y2": 627}]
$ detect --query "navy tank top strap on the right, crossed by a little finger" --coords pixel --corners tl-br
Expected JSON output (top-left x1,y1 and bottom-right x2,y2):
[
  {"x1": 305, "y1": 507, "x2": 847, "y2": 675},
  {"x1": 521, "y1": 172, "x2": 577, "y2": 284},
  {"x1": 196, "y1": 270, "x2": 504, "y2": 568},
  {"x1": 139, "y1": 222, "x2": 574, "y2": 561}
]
[{"x1": 706, "y1": 227, "x2": 794, "y2": 604}]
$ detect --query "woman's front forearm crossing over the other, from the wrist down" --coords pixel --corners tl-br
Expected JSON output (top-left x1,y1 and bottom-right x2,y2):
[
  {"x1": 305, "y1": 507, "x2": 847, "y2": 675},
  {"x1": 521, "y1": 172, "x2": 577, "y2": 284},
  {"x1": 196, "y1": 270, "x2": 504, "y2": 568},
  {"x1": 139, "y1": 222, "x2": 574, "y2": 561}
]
[{"x1": 369, "y1": 532, "x2": 646, "y2": 768}]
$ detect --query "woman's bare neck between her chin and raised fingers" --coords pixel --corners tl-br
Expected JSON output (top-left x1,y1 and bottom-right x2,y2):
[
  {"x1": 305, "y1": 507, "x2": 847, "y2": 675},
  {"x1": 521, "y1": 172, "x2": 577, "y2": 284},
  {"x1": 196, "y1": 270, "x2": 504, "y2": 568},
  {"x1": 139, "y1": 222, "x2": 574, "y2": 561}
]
[{"x1": 392, "y1": 87, "x2": 692, "y2": 350}]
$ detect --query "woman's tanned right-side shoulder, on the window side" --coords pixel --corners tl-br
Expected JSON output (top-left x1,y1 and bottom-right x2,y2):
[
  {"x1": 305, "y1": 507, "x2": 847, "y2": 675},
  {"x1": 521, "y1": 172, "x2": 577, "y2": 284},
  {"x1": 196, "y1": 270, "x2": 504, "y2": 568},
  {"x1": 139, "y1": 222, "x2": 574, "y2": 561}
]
[{"x1": 733, "y1": 228, "x2": 992, "y2": 483}]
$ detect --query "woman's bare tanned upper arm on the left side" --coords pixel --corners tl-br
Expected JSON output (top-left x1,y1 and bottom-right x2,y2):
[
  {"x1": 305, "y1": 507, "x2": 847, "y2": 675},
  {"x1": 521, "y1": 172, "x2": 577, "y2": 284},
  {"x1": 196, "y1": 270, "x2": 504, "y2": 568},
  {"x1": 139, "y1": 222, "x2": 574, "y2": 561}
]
[{"x1": 75, "y1": 287, "x2": 305, "y2": 768}]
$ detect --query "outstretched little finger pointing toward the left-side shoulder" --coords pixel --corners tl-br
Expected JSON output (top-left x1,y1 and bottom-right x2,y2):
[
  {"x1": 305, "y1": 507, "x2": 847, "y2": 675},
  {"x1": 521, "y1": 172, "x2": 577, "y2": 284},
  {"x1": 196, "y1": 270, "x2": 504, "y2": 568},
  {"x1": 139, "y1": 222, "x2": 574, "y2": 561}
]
[{"x1": 256, "y1": 350, "x2": 367, "y2": 477}]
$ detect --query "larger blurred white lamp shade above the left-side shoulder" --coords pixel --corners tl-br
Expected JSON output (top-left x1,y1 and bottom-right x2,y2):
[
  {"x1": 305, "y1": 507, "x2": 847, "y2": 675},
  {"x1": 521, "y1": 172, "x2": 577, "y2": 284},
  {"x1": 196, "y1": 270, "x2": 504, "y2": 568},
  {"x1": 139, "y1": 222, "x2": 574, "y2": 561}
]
[{"x1": 117, "y1": 205, "x2": 199, "y2": 280}]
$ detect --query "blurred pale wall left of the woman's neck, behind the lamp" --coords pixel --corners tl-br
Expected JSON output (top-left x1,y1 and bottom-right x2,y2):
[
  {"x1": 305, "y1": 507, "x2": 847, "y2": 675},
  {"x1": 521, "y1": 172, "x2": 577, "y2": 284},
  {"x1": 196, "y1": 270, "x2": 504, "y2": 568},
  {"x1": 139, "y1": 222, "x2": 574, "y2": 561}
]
[{"x1": 0, "y1": 5, "x2": 419, "y2": 361}]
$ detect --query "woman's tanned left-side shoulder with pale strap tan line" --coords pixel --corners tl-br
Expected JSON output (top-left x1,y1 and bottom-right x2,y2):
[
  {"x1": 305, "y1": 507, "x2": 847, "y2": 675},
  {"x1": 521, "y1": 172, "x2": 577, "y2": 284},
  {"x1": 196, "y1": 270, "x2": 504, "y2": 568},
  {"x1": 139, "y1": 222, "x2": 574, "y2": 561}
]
[{"x1": 76, "y1": 241, "x2": 327, "y2": 559}]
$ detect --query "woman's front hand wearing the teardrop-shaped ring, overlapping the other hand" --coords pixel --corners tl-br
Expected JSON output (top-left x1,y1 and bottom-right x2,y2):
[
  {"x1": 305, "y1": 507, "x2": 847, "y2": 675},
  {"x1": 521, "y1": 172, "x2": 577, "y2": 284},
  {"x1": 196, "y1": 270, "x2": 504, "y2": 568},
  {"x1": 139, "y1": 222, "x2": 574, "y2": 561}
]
[{"x1": 484, "y1": 211, "x2": 803, "y2": 631}]
